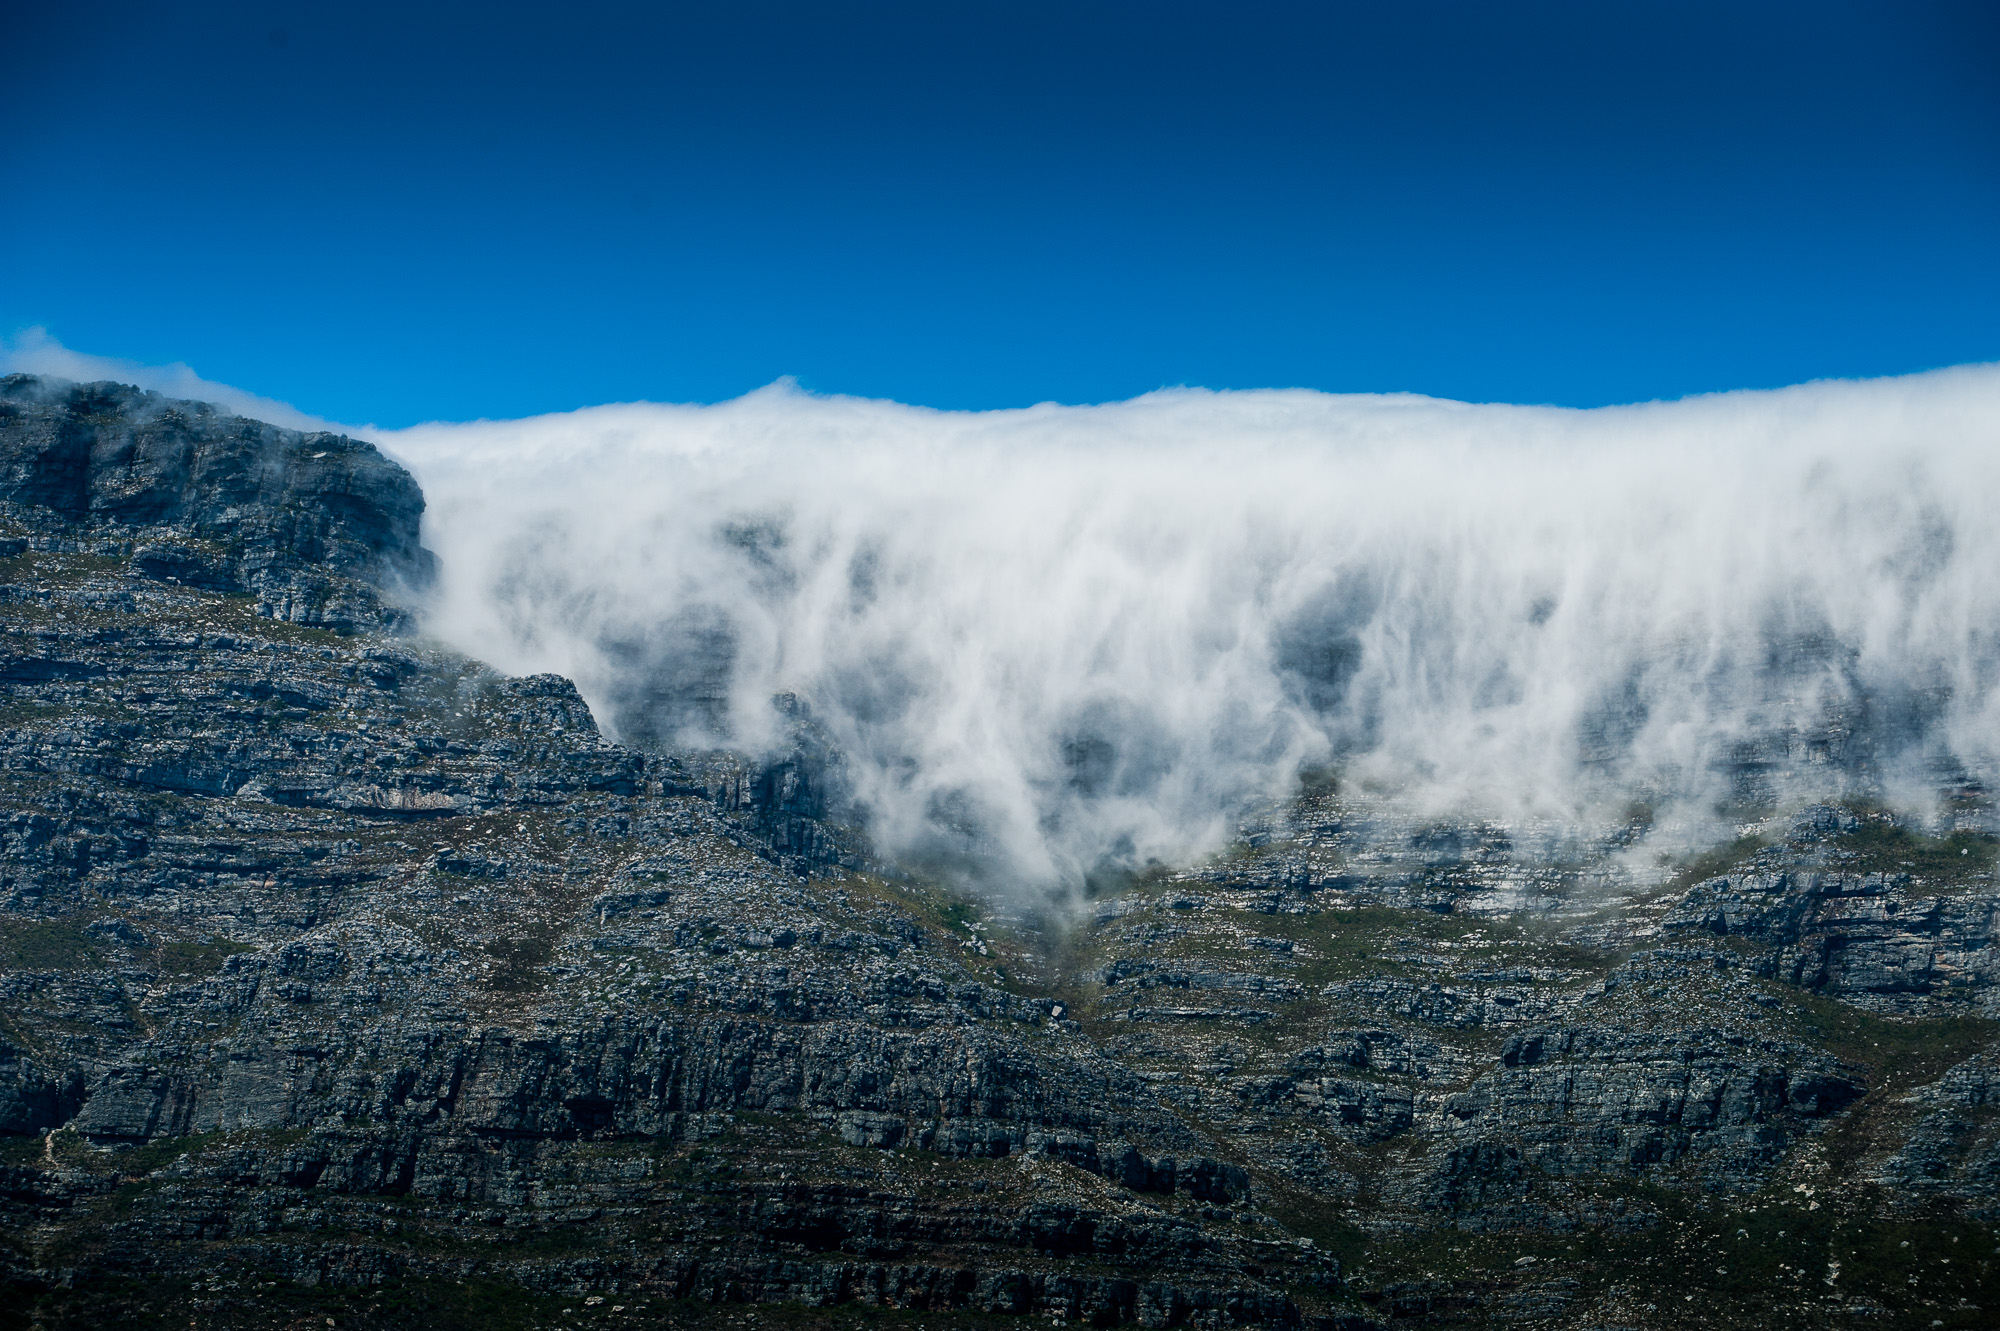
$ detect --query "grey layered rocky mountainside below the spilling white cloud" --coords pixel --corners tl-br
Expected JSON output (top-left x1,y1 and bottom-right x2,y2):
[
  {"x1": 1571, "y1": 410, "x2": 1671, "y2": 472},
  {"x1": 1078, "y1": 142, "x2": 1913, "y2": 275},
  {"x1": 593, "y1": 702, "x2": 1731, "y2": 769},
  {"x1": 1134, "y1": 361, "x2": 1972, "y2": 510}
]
[{"x1": 0, "y1": 378, "x2": 2000, "y2": 1327}]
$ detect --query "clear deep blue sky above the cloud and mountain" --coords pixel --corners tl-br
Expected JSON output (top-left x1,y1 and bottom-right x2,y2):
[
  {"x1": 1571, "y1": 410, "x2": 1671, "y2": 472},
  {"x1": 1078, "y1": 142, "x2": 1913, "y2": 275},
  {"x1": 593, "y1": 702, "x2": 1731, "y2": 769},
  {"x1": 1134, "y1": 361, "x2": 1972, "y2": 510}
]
[{"x1": 0, "y1": 0, "x2": 2000, "y2": 426}]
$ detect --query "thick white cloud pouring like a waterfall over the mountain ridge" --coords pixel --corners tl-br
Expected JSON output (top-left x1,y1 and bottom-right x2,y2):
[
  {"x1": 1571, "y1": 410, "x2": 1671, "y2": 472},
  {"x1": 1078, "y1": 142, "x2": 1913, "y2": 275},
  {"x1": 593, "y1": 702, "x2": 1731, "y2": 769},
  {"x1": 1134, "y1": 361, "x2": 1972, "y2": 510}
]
[{"x1": 378, "y1": 368, "x2": 2000, "y2": 881}]
